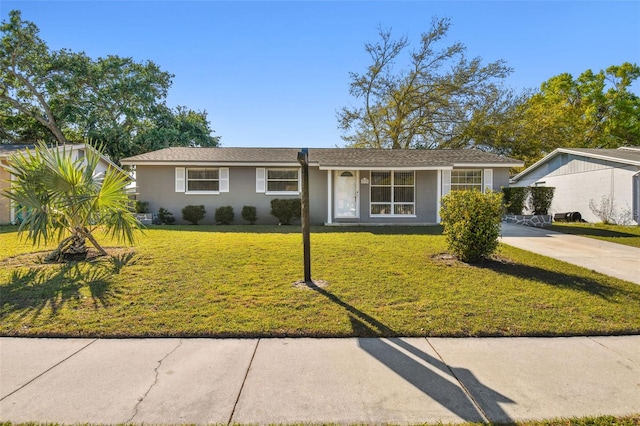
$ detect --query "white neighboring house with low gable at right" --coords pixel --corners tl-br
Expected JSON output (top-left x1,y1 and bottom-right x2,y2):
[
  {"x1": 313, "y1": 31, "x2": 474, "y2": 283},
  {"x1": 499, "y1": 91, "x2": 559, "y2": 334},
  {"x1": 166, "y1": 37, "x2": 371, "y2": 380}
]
[{"x1": 510, "y1": 147, "x2": 640, "y2": 224}]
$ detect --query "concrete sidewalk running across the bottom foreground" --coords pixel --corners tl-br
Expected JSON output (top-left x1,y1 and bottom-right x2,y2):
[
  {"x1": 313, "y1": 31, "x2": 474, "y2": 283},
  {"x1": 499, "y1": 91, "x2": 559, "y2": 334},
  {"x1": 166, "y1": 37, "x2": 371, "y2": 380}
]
[{"x1": 0, "y1": 336, "x2": 640, "y2": 424}]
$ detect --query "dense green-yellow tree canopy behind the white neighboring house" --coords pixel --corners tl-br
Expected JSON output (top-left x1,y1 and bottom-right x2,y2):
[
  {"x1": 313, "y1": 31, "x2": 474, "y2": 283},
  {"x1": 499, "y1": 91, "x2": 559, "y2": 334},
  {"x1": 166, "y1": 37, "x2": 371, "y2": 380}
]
[{"x1": 459, "y1": 62, "x2": 640, "y2": 165}]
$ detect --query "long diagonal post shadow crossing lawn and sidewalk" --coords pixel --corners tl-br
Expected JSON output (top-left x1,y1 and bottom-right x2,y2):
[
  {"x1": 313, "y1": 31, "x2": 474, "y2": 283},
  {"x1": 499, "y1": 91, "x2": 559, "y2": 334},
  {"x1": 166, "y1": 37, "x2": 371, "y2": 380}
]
[{"x1": 307, "y1": 282, "x2": 514, "y2": 422}]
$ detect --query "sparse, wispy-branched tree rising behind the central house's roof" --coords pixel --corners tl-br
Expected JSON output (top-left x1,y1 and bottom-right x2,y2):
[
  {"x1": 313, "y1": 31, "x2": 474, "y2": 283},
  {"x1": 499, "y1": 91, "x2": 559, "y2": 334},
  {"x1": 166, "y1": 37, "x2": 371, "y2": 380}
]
[{"x1": 338, "y1": 19, "x2": 511, "y2": 149}]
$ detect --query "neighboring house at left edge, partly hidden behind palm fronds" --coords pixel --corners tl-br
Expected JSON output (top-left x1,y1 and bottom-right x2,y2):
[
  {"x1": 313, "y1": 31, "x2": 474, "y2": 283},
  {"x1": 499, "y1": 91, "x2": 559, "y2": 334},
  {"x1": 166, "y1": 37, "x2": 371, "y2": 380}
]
[{"x1": 0, "y1": 144, "x2": 125, "y2": 225}]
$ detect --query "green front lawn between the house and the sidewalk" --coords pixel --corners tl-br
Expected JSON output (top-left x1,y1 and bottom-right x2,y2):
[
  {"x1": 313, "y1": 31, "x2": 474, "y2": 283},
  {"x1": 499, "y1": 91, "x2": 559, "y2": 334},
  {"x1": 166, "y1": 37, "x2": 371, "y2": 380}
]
[{"x1": 0, "y1": 226, "x2": 640, "y2": 337}]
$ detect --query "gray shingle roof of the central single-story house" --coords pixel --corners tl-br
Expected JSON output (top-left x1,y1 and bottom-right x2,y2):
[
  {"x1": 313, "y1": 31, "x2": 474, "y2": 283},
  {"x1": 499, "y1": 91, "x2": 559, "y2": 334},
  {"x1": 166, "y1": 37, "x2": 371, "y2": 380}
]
[{"x1": 121, "y1": 147, "x2": 522, "y2": 168}]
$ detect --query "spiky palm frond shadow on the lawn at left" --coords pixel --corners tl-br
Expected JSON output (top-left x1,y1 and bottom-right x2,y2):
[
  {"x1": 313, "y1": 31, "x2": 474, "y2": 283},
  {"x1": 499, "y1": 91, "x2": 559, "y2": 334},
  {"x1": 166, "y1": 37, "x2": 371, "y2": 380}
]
[{"x1": 0, "y1": 253, "x2": 133, "y2": 318}]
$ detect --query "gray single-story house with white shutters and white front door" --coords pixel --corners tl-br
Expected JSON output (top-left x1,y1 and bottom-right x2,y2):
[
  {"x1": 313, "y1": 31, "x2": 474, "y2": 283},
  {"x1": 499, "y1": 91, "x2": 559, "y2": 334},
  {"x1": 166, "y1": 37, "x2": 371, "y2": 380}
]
[{"x1": 121, "y1": 148, "x2": 523, "y2": 225}]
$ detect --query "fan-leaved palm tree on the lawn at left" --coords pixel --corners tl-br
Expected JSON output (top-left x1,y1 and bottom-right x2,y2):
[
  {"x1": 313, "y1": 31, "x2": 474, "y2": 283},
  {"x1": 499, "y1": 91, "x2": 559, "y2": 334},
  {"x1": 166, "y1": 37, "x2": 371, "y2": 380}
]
[{"x1": 5, "y1": 143, "x2": 141, "y2": 262}]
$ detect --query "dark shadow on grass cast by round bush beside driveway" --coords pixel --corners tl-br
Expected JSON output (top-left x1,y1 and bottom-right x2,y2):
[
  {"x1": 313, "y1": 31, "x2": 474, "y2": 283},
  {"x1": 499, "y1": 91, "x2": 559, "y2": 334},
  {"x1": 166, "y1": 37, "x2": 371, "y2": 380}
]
[{"x1": 473, "y1": 259, "x2": 640, "y2": 302}]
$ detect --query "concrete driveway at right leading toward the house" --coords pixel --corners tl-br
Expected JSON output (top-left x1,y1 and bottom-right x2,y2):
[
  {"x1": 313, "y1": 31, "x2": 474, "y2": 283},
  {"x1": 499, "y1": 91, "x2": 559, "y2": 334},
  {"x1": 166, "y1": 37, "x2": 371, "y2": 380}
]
[{"x1": 500, "y1": 223, "x2": 640, "y2": 284}]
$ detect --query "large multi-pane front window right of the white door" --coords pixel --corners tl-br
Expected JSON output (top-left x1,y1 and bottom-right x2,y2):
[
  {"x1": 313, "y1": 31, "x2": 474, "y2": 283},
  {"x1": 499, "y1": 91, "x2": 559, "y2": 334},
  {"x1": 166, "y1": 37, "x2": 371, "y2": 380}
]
[{"x1": 371, "y1": 171, "x2": 415, "y2": 215}]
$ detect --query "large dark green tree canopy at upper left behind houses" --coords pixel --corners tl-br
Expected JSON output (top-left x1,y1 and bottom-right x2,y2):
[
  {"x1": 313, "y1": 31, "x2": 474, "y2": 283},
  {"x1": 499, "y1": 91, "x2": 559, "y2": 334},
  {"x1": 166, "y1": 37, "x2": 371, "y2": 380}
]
[{"x1": 0, "y1": 10, "x2": 219, "y2": 161}]
